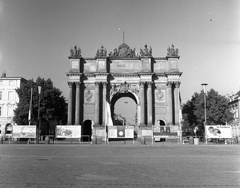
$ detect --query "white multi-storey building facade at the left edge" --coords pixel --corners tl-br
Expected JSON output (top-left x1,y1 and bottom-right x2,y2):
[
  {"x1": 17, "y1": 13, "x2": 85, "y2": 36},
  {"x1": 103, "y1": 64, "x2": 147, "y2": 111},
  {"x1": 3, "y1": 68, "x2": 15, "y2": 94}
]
[{"x1": 0, "y1": 73, "x2": 27, "y2": 134}]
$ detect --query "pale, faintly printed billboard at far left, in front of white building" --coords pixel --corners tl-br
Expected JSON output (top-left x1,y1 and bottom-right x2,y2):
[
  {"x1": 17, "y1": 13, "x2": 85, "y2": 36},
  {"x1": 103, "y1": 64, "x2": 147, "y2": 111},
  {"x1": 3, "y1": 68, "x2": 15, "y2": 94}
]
[{"x1": 12, "y1": 125, "x2": 36, "y2": 138}]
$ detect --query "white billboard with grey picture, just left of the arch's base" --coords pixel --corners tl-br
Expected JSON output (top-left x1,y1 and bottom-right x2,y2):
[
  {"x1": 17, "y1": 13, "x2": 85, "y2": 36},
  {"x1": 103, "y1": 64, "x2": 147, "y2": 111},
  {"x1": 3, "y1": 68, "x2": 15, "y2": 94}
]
[{"x1": 56, "y1": 125, "x2": 81, "y2": 138}]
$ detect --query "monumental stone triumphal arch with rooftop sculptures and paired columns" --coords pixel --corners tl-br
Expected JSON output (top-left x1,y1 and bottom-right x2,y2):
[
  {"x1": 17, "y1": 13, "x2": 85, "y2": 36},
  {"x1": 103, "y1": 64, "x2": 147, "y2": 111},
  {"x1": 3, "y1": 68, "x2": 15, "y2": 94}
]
[{"x1": 66, "y1": 43, "x2": 182, "y2": 140}]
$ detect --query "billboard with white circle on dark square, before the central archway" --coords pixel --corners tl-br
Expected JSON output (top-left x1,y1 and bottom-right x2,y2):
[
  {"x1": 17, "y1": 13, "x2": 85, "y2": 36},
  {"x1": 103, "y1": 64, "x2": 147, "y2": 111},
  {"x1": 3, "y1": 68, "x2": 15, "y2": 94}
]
[{"x1": 108, "y1": 126, "x2": 134, "y2": 138}]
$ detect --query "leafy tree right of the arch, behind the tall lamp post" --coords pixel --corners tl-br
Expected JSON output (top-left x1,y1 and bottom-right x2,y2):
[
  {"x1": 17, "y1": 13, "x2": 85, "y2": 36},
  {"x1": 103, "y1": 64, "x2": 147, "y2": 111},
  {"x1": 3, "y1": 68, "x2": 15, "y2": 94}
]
[{"x1": 182, "y1": 89, "x2": 233, "y2": 131}]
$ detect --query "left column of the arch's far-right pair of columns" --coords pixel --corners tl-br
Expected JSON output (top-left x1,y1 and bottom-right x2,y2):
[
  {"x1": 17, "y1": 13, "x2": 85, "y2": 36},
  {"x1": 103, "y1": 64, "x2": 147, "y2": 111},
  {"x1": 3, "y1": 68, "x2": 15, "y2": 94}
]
[{"x1": 167, "y1": 82, "x2": 173, "y2": 125}]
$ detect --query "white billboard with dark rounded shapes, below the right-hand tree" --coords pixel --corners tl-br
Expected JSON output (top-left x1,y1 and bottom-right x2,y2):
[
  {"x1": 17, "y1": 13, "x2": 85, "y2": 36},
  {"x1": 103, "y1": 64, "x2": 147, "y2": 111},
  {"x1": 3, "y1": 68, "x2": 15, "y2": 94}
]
[{"x1": 206, "y1": 125, "x2": 232, "y2": 138}]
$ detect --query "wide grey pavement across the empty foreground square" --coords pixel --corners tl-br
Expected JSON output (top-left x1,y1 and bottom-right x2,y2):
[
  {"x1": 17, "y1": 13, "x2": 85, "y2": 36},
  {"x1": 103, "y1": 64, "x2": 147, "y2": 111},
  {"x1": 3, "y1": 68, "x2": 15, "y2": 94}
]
[{"x1": 0, "y1": 144, "x2": 240, "y2": 188}]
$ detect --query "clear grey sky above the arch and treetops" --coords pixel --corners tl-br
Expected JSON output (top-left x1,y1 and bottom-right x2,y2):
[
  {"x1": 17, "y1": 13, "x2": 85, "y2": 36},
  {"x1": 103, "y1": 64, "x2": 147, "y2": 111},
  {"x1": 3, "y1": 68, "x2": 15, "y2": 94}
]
[{"x1": 0, "y1": 0, "x2": 240, "y2": 122}]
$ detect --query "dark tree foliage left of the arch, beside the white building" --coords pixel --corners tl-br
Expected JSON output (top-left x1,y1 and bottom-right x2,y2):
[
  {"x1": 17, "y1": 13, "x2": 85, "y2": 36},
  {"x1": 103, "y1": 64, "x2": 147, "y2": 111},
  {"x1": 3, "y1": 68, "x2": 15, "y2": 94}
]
[{"x1": 14, "y1": 77, "x2": 67, "y2": 125}]
